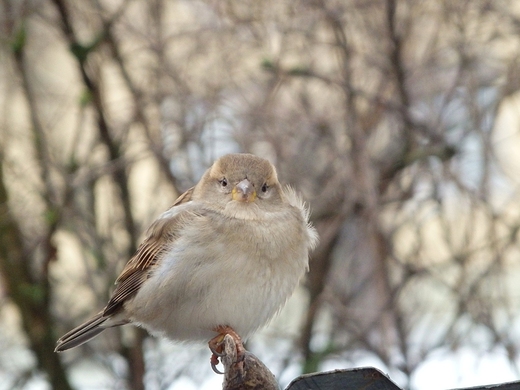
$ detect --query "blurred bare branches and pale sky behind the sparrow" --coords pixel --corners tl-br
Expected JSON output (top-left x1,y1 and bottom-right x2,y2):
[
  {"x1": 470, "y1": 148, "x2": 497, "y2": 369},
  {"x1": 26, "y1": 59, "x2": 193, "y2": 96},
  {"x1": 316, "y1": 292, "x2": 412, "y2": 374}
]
[{"x1": 0, "y1": 0, "x2": 520, "y2": 390}]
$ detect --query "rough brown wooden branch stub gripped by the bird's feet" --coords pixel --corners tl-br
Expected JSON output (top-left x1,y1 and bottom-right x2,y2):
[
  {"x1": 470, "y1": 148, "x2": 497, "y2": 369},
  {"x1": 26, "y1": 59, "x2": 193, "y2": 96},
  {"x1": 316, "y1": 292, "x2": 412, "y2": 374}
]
[{"x1": 220, "y1": 335, "x2": 279, "y2": 390}]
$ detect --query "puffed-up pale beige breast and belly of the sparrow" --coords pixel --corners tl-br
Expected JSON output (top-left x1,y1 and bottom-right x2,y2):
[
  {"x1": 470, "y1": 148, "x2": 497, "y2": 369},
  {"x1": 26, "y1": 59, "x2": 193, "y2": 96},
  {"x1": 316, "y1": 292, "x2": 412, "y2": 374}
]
[{"x1": 129, "y1": 207, "x2": 308, "y2": 340}]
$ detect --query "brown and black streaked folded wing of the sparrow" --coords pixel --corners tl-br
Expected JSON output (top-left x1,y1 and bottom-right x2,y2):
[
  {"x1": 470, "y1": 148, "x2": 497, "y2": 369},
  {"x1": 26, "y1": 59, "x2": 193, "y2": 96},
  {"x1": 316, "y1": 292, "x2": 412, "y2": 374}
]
[{"x1": 103, "y1": 188, "x2": 196, "y2": 317}]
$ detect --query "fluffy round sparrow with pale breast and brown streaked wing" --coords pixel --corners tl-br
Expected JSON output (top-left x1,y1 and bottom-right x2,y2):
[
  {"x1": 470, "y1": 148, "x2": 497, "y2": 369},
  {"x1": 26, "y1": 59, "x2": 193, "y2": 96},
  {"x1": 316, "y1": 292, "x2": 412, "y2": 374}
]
[{"x1": 55, "y1": 153, "x2": 318, "y2": 372}]
